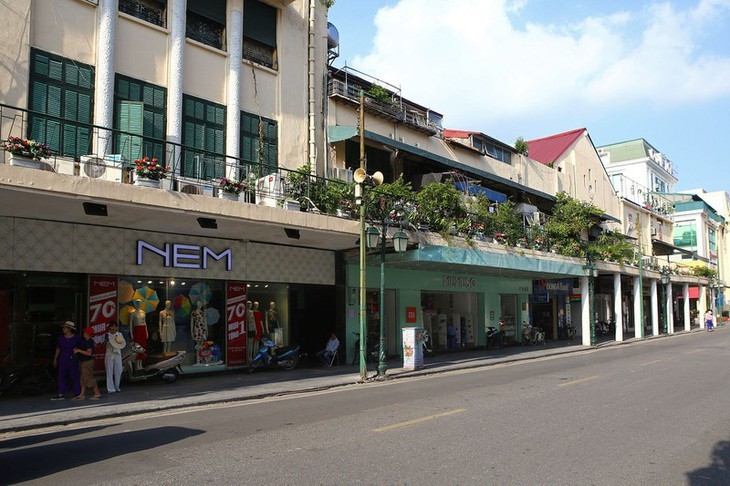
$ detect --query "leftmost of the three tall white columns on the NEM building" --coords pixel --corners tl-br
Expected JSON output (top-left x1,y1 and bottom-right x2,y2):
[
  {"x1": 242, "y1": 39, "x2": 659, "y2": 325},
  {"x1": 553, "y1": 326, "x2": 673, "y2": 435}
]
[{"x1": 93, "y1": 0, "x2": 119, "y2": 156}]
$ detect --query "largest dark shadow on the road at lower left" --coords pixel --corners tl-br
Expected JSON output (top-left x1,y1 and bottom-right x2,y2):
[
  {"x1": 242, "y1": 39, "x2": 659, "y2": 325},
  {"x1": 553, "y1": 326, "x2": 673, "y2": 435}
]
[{"x1": 0, "y1": 427, "x2": 204, "y2": 484}]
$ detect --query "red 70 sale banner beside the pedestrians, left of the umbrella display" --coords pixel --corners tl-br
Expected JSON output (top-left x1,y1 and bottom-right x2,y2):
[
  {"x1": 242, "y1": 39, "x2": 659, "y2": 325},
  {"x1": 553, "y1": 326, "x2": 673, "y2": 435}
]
[{"x1": 89, "y1": 275, "x2": 118, "y2": 375}]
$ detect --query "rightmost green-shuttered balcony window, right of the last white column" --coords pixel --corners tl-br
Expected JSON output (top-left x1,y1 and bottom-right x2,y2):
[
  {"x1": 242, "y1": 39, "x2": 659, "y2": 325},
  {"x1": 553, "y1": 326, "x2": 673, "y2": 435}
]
[{"x1": 241, "y1": 112, "x2": 279, "y2": 173}]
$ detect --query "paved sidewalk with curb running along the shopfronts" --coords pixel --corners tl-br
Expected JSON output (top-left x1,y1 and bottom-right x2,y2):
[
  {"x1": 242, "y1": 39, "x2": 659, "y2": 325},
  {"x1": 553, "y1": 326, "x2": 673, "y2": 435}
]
[{"x1": 0, "y1": 340, "x2": 636, "y2": 434}]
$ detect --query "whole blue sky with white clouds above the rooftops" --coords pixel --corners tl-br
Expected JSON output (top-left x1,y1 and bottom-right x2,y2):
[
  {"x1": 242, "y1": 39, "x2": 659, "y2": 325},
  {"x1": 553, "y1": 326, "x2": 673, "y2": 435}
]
[{"x1": 329, "y1": 0, "x2": 730, "y2": 192}]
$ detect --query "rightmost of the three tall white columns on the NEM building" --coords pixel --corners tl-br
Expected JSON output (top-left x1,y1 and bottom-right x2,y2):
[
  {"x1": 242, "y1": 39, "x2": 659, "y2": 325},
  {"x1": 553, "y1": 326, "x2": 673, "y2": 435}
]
[{"x1": 226, "y1": 0, "x2": 243, "y2": 179}]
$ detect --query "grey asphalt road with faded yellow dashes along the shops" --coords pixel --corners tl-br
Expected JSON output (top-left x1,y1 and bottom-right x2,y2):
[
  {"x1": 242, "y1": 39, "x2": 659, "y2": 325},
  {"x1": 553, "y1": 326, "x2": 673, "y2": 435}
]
[{"x1": 0, "y1": 329, "x2": 730, "y2": 485}]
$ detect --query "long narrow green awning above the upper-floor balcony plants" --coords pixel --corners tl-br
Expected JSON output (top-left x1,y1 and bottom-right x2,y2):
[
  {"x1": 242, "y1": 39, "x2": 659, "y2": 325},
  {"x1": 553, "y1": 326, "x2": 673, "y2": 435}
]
[{"x1": 327, "y1": 125, "x2": 556, "y2": 201}]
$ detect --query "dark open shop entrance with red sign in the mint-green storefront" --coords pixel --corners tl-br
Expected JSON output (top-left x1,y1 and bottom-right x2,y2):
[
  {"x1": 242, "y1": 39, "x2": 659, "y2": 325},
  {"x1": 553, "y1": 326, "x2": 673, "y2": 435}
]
[{"x1": 421, "y1": 292, "x2": 477, "y2": 351}]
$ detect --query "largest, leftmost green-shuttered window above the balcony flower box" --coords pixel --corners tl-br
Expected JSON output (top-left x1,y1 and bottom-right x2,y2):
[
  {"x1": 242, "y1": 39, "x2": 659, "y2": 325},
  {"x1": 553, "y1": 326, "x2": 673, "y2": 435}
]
[{"x1": 28, "y1": 49, "x2": 94, "y2": 157}]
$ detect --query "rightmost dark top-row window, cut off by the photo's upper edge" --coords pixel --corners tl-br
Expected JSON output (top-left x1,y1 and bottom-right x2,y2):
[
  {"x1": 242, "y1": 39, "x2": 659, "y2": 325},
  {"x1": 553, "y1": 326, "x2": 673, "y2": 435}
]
[{"x1": 243, "y1": 0, "x2": 278, "y2": 69}]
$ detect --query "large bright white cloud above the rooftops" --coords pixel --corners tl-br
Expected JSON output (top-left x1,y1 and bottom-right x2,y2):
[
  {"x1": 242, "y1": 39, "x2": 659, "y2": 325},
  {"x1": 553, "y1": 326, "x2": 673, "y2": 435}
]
[{"x1": 354, "y1": 0, "x2": 730, "y2": 129}]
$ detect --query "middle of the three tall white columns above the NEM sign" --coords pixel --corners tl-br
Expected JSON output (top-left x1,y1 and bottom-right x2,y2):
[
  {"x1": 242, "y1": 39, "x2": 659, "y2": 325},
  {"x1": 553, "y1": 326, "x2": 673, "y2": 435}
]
[{"x1": 167, "y1": 0, "x2": 187, "y2": 175}]
